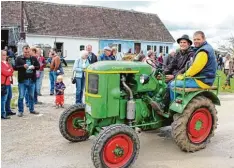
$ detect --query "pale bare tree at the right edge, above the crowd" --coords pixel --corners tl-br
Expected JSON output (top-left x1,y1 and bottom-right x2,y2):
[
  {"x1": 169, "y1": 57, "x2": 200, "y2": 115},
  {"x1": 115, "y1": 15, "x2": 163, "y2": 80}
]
[{"x1": 218, "y1": 35, "x2": 234, "y2": 56}]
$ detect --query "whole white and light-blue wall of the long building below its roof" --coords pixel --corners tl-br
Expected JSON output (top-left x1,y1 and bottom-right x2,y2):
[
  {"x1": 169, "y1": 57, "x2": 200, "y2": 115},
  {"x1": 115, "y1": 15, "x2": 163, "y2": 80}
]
[{"x1": 26, "y1": 34, "x2": 173, "y2": 60}]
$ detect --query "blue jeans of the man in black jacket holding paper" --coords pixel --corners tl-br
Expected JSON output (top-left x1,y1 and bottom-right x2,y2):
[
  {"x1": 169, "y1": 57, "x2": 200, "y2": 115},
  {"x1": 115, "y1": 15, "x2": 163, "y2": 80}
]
[{"x1": 18, "y1": 79, "x2": 35, "y2": 113}]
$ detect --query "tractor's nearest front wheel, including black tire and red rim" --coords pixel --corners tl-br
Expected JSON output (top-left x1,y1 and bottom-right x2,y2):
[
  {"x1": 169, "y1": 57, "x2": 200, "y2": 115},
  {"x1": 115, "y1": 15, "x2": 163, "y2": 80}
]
[{"x1": 91, "y1": 124, "x2": 140, "y2": 168}]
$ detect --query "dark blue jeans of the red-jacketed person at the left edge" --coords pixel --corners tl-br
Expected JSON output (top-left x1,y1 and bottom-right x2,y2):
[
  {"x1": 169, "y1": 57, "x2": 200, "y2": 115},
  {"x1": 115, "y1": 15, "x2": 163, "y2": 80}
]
[{"x1": 1, "y1": 85, "x2": 12, "y2": 117}]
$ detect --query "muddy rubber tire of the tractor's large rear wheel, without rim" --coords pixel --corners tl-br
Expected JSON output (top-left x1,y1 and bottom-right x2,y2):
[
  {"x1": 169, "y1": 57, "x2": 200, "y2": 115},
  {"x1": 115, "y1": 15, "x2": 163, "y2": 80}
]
[{"x1": 171, "y1": 96, "x2": 218, "y2": 152}]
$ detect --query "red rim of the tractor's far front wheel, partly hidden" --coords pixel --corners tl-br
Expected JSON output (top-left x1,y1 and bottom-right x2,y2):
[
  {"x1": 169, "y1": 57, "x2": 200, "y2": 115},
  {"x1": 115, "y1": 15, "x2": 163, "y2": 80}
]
[{"x1": 66, "y1": 111, "x2": 87, "y2": 137}]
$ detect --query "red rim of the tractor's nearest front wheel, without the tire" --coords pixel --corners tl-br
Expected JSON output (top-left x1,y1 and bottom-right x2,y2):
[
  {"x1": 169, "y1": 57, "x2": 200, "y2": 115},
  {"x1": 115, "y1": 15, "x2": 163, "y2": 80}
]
[{"x1": 102, "y1": 134, "x2": 133, "y2": 168}]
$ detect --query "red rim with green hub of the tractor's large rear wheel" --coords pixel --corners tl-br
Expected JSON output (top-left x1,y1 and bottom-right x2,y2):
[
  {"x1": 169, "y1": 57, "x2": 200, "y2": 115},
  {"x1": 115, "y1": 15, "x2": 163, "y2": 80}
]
[{"x1": 188, "y1": 108, "x2": 213, "y2": 143}]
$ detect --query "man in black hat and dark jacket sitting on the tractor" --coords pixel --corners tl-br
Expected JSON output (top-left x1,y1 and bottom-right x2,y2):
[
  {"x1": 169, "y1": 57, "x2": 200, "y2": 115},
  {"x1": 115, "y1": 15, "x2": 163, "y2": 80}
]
[{"x1": 164, "y1": 35, "x2": 194, "y2": 111}]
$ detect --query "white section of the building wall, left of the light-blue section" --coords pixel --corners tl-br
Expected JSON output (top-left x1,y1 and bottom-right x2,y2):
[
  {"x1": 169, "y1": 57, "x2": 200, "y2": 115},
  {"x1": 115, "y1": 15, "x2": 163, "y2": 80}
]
[{"x1": 26, "y1": 34, "x2": 99, "y2": 60}]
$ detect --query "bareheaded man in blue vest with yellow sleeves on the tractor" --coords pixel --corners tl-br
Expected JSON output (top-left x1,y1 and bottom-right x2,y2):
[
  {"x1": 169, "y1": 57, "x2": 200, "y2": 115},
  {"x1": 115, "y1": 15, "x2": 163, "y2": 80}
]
[{"x1": 170, "y1": 31, "x2": 217, "y2": 100}]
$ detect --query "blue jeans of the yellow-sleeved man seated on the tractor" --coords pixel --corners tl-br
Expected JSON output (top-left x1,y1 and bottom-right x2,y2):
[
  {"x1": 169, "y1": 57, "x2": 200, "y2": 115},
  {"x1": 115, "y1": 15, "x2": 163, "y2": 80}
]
[{"x1": 169, "y1": 78, "x2": 199, "y2": 101}]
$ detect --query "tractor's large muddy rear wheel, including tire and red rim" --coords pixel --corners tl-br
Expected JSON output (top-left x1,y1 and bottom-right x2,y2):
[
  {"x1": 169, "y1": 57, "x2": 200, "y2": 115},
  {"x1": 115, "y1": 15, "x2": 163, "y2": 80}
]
[{"x1": 171, "y1": 96, "x2": 218, "y2": 152}]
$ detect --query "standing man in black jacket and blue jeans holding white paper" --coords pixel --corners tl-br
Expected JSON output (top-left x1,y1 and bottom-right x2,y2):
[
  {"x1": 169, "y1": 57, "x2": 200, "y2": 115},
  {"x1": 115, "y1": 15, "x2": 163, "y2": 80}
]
[{"x1": 14, "y1": 46, "x2": 40, "y2": 117}]
